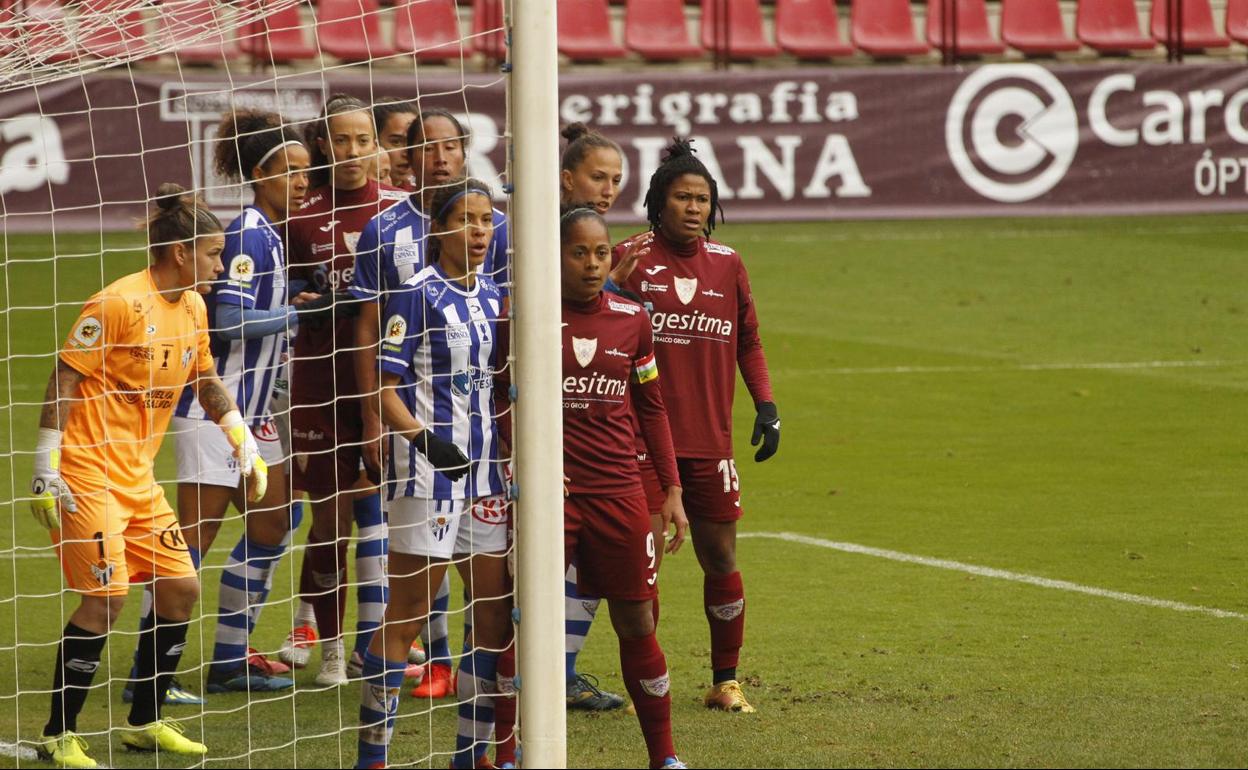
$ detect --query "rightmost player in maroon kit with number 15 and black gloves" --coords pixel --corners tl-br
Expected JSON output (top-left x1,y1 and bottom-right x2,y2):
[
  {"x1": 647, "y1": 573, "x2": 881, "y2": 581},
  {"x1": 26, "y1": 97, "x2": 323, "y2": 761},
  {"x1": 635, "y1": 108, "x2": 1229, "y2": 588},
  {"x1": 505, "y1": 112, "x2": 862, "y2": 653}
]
[{"x1": 614, "y1": 140, "x2": 780, "y2": 713}]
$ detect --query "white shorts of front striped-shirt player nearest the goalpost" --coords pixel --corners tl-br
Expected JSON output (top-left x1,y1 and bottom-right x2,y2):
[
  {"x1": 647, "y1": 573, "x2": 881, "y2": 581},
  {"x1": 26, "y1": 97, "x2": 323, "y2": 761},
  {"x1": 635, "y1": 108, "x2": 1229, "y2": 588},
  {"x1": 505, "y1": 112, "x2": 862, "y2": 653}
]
[{"x1": 389, "y1": 495, "x2": 509, "y2": 559}]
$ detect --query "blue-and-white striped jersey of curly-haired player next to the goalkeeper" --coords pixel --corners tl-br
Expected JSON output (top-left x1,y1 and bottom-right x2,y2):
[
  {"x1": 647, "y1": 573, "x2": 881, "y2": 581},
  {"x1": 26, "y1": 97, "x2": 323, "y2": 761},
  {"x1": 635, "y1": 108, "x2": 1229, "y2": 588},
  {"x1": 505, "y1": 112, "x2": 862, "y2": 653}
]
[{"x1": 175, "y1": 206, "x2": 288, "y2": 426}]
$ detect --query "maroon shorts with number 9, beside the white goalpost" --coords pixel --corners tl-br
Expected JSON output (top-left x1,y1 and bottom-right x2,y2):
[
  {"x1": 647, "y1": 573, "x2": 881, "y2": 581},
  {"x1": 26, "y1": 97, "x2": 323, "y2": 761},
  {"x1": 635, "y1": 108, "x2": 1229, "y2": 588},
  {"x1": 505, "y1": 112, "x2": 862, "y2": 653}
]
[{"x1": 563, "y1": 494, "x2": 659, "y2": 602}]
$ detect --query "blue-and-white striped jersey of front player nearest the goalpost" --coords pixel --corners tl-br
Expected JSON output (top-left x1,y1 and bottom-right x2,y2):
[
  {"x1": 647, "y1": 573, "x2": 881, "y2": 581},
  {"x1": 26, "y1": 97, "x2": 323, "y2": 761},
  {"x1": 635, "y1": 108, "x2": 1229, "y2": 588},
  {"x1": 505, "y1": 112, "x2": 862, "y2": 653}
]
[{"x1": 378, "y1": 265, "x2": 505, "y2": 500}]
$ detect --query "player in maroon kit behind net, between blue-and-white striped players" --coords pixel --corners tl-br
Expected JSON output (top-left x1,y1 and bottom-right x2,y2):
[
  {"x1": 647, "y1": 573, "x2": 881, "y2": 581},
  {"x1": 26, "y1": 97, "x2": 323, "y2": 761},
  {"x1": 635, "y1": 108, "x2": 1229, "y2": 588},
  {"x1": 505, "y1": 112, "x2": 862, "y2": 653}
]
[{"x1": 282, "y1": 95, "x2": 404, "y2": 685}]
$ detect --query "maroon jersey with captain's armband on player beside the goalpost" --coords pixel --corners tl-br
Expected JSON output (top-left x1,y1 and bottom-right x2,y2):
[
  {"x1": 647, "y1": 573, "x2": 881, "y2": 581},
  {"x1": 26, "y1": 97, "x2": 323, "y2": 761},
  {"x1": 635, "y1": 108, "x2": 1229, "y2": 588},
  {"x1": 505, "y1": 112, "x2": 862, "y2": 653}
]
[{"x1": 562, "y1": 293, "x2": 679, "y2": 495}]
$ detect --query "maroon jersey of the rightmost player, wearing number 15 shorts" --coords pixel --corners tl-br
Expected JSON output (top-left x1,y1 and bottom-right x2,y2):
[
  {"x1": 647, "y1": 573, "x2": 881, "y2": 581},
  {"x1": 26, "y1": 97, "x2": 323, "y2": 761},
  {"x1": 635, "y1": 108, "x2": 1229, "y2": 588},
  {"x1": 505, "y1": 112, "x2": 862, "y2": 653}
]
[{"x1": 615, "y1": 228, "x2": 775, "y2": 459}]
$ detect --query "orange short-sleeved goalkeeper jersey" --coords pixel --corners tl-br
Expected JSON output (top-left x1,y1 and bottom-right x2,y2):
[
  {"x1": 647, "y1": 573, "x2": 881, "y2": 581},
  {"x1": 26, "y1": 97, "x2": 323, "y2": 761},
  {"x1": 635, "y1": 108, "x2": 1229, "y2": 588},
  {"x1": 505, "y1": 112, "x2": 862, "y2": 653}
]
[{"x1": 60, "y1": 270, "x2": 213, "y2": 490}]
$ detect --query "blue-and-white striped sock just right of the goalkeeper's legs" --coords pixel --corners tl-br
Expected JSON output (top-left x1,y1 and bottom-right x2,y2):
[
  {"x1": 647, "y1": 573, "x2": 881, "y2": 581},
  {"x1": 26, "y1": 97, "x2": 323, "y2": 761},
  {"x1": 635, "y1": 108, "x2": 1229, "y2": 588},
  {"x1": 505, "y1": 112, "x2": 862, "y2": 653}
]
[{"x1": 212, "y1": 535, "x2": 286, "y2": 673}]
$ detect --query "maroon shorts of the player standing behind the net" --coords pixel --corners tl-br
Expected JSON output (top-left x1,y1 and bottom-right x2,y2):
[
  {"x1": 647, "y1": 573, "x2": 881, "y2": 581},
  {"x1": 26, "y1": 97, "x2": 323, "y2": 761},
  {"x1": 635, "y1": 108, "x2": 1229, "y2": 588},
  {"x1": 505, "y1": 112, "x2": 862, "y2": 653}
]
[{"x1": 291, "y1": 397, "x2": 381, "y2": 499}]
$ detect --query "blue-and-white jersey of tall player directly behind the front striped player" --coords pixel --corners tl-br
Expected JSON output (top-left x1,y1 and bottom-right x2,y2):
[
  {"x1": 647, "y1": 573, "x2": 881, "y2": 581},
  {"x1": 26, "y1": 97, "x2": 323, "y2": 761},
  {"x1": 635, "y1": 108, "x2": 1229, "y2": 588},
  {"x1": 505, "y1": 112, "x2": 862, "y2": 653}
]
[{"x1": 349, "y1": 195, "x2": 510, "y2": 303}]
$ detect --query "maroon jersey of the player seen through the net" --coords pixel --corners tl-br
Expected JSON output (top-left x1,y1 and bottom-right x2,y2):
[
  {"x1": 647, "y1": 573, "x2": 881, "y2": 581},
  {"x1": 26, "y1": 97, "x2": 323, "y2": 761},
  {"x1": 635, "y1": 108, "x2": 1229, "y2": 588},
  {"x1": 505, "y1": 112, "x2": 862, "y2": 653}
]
[{"x1": 286, "y1": 180, "x2": 407, "y2": 403}]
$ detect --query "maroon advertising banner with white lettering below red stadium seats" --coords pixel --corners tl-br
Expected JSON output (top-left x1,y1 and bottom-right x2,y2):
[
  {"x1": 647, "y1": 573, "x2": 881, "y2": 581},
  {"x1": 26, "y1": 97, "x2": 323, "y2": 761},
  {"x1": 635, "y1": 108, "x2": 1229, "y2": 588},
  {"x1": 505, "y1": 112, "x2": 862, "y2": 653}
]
[{"x1": 0, "y1": 62, "x2": 1248, "y2": 231}]
